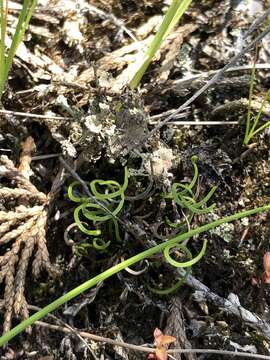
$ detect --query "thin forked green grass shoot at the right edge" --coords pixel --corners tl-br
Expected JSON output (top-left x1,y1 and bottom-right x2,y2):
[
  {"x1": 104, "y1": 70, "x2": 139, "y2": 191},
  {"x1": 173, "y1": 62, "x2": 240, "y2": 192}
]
[{"x1": 244, "y1": 52, "x2": 270, "y2": 146}]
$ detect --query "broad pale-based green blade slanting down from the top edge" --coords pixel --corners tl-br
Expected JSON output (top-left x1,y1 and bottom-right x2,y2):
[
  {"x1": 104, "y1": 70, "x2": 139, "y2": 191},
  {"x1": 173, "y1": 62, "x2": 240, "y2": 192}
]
[{"x1": 130, "y1": 0, "x2": 192, "y2": 89}]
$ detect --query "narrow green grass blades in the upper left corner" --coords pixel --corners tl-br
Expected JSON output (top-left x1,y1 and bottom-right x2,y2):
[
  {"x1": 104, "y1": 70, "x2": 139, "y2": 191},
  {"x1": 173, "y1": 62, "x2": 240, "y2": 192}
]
[{"x1": 0, "y1": 0, "x2": 37, "y2": 101}]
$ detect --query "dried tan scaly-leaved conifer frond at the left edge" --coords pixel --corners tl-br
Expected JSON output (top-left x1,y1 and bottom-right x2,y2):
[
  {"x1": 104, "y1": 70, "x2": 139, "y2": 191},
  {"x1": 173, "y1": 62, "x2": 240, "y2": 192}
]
[{"x1": 0, "y1": 137, "x2": 53, "y2": 332}]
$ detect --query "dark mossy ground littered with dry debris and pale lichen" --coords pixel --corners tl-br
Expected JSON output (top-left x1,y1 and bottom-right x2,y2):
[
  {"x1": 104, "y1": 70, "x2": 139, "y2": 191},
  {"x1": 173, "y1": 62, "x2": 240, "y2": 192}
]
[{"x1": 0, "y1": 0, "x2": 270, "y2": 360}]
